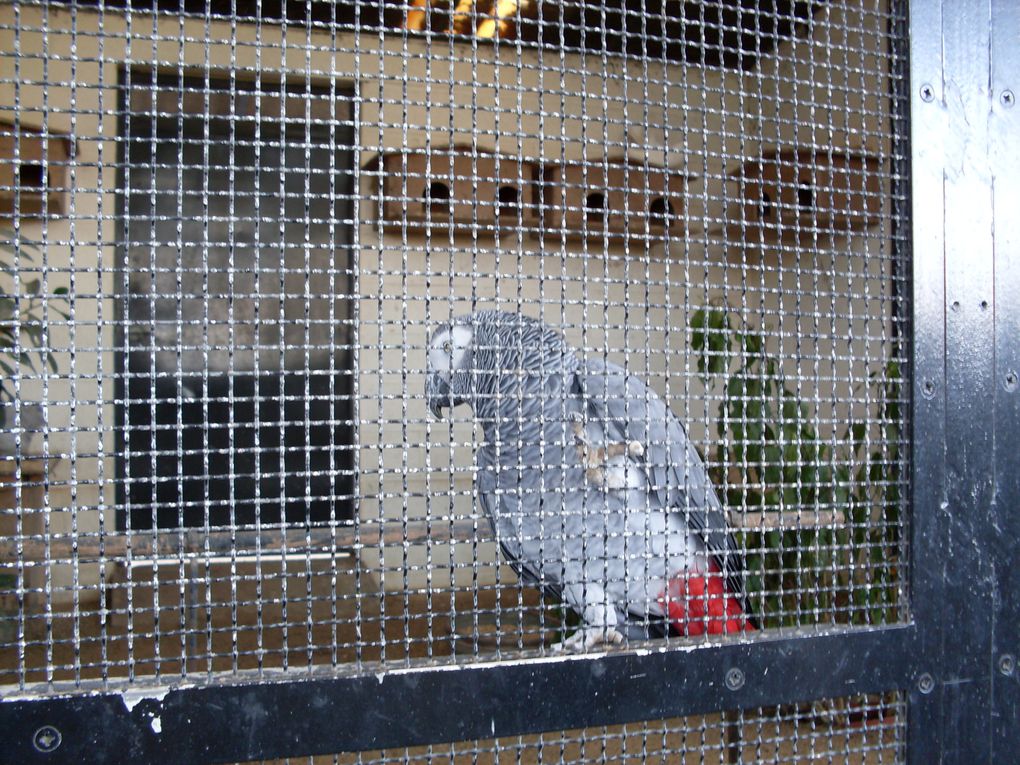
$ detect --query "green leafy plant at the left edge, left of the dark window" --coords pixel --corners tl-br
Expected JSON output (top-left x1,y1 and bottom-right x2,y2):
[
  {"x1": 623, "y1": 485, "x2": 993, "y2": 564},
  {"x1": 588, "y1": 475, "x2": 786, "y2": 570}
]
[{"x1": 0, "y1": 228, "x2": 70, "y2": 417}]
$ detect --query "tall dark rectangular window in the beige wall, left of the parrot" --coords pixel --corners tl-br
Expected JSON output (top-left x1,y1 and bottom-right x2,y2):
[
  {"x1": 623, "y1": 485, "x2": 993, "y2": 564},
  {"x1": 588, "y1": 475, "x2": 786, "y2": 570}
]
[{"x1": 117, "y1": 69, "x2": 354, "y2": 529}]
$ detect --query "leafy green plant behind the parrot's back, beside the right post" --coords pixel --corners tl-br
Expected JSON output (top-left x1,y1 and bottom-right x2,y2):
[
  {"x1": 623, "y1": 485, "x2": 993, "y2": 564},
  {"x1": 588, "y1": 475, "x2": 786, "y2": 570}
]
[{"x1": 691, "y1": 308, "x2": 902, "y2": 627}]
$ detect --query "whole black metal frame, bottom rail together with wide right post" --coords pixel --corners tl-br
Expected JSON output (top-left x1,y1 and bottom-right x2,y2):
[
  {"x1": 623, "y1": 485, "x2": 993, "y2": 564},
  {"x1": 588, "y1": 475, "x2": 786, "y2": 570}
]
[{"x1": 0, "y1": 0, "x2": 1020, "y2": 763}]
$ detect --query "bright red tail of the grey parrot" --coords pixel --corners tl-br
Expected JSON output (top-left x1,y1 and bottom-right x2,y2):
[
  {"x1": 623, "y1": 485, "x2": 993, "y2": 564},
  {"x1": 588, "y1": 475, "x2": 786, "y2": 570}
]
[{"x1": 659, "y1": 563, "x2": 754, "y2": 636}]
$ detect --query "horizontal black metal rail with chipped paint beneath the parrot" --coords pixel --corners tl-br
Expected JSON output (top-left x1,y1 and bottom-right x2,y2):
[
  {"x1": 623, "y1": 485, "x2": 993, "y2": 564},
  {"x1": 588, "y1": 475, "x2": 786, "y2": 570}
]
[{"x1": 0, "y1": 625, "x2": 920, "y2": 763}]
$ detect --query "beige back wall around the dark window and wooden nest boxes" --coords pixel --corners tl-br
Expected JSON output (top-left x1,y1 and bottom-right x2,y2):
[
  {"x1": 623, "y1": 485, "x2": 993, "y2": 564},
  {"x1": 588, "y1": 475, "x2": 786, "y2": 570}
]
[{"x1": 0, "y1": 0, "x2": 889, "y2": 589}]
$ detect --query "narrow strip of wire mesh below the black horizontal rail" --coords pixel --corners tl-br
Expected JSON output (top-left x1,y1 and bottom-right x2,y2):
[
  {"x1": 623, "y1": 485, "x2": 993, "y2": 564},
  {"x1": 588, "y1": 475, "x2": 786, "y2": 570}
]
[{"x1": 269, "y1": 695, "x2": 906, "y2": 765}]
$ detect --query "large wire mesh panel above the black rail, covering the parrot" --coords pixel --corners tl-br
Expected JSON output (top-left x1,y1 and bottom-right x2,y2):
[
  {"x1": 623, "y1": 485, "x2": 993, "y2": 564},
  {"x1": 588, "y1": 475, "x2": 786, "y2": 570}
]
[{"x1": 0, "y1": 0, "x2": 909, "y2": 730}]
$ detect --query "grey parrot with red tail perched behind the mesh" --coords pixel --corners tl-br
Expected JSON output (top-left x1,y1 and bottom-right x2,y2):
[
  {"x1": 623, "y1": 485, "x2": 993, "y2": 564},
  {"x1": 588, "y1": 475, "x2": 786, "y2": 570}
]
[{"x1": 425, "y1": 311, "x2": 753, "y2": 650}]
